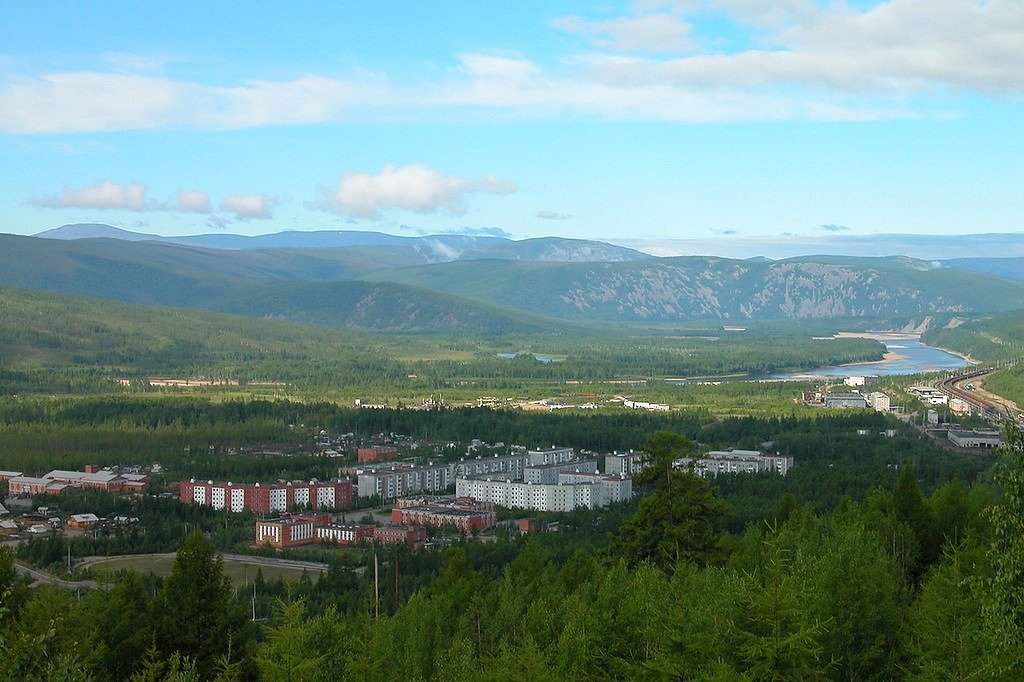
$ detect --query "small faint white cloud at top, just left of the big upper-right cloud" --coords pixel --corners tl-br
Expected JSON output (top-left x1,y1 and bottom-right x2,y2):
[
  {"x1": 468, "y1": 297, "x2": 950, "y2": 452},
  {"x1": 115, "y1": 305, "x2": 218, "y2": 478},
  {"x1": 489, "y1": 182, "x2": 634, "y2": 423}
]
[{"x1": 551, "y1": 13, "x2": 694, "y2": 52}]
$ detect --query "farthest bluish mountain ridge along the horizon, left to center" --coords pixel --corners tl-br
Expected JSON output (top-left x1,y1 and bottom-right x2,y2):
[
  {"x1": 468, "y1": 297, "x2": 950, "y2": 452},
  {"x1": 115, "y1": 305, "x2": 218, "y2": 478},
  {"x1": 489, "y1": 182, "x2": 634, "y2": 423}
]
[{"x1": 36, "y1": 223, "x2": 648, "y2": 263}]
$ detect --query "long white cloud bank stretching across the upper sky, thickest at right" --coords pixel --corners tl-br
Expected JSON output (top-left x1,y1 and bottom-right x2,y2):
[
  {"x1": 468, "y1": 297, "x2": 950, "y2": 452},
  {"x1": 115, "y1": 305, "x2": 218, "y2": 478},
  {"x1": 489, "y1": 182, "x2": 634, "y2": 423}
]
[{"x1": 0, "y1": 0, "x2": 1024, "y2": 133}]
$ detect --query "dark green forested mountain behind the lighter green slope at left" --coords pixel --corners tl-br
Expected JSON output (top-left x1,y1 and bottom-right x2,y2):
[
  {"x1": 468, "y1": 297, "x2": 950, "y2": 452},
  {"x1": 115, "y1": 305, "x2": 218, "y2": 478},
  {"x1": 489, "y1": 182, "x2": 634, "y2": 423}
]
[{"x1": 0, "y1": 235, "x2": 561, "y2": 334}]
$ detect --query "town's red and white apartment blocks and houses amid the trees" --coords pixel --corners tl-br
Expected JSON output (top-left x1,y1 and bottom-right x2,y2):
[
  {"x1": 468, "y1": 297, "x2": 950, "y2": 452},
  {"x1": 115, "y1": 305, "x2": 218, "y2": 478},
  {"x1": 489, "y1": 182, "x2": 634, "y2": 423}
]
[{"x1": 0, "y1": 441, "x2": 793, "y2": 549}]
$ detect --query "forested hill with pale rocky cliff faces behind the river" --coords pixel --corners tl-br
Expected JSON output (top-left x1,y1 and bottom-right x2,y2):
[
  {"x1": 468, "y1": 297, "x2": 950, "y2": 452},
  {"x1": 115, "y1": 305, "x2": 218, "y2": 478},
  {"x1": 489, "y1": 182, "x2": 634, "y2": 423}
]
[{"x1": 368, "y1": 256, "x2": 1024, "y2": 323}]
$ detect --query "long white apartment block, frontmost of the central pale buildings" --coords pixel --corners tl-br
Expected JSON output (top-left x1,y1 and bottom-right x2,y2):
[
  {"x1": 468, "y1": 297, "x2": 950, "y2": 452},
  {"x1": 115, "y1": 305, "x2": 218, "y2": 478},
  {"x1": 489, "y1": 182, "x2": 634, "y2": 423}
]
[{"x1": 456, "y1": 472, "x2": 633, "y2": 512}]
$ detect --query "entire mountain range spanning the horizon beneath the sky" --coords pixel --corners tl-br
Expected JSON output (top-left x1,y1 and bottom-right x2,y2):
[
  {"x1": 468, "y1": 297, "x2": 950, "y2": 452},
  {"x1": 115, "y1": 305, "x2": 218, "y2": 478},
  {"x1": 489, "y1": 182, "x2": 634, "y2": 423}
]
[{"x1": 0, "y1": 224, "x2": 1024, "y2": 334}]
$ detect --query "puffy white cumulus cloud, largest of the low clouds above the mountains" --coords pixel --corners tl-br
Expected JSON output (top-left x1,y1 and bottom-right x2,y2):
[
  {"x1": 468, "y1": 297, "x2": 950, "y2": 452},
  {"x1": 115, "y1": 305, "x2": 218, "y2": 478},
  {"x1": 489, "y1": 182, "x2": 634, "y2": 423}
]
[{"x1": 327, "y1": 164, "x2": 517, "y2": 218}]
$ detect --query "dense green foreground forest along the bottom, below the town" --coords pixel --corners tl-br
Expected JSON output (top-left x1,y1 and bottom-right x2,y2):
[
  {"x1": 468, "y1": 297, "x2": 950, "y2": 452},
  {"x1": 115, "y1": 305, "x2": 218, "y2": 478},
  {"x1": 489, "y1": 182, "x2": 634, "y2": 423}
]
[{"x1": 0, "y1": 429, "x2": 1024, "y2": 680}]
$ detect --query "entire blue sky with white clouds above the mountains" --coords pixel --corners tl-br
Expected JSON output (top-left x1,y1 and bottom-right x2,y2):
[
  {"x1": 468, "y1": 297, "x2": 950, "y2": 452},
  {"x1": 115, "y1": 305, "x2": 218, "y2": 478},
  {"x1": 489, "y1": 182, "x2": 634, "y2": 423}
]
[{"x1": 0, "y1": 0, "x2": 1024, "y2": 241}]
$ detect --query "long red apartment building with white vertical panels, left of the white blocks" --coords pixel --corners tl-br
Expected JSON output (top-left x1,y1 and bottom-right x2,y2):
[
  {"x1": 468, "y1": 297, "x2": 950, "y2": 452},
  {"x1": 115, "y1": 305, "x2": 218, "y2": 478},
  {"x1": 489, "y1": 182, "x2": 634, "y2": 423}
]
[{"x1": 178, "y1": 478, "x2": 352, "y2": 514}]
